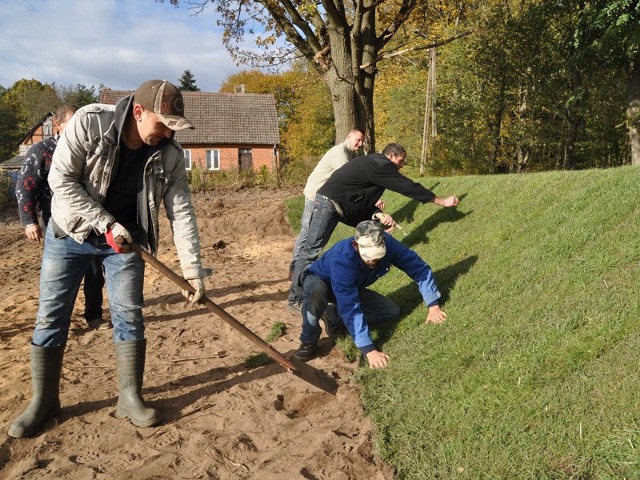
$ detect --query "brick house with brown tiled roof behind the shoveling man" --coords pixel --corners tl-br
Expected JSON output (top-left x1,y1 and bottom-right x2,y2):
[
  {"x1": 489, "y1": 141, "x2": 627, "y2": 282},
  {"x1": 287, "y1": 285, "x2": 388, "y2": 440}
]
[{"x1": 100, "y1": 87, "x2": 280, "y2": 171}]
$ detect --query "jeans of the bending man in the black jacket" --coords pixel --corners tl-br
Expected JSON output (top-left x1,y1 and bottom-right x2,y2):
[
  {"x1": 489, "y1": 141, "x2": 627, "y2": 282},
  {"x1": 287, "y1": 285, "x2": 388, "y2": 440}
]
[{"x1": 289, "y1": 194, "x2": 341, "y2": 302}]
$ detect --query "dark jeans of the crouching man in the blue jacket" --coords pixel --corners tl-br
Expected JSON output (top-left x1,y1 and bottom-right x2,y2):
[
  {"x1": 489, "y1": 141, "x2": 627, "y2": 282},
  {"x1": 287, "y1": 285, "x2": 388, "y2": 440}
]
[{"x1": 300, "y1": 274, "x2": 400, "y2": 345}]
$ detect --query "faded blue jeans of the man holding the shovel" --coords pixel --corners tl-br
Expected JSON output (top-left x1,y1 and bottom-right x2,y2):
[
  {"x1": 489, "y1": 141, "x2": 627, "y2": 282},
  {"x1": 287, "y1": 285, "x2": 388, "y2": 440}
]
[{"x1": 32, "y1": 228, "x2": 144, "y2": 347}]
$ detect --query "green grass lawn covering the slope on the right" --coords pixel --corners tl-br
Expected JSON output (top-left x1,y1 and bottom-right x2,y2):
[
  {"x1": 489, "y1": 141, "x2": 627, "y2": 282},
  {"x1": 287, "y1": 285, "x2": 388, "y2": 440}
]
[{"x1": 289, "y1": 167, "x2": 640, "y2": 480}]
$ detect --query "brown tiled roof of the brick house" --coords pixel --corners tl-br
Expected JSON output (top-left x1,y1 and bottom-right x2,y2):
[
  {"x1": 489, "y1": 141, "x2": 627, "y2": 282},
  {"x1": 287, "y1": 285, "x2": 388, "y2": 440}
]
[{"x1": 100, "y1": 88, "x2": 280, "y2": 145}]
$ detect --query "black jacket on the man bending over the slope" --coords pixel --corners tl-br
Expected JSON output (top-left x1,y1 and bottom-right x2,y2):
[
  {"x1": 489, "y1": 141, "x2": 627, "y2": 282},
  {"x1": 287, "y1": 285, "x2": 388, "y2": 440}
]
[{"x1": 318, "y1": 153, "x2": 435, "y2": 227}]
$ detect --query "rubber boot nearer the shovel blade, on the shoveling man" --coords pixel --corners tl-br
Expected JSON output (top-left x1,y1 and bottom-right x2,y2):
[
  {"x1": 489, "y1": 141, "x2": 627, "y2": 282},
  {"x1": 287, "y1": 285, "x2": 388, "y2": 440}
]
[{"x1": 116, "y1": 339, "x2": 160, "y2": 427}]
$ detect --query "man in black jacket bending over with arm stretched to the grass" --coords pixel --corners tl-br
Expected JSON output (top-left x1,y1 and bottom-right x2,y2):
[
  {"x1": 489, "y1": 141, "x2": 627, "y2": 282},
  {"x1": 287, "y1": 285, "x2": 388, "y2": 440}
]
[{"x1": 289, "y1": 143, "x2": 458, "y2": 311}]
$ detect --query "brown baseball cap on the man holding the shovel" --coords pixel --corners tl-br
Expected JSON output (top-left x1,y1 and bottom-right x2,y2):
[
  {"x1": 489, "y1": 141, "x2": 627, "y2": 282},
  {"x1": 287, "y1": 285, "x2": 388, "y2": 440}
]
[{"x1": 133, "y1": 80, "x2": 194, "y2": 131}]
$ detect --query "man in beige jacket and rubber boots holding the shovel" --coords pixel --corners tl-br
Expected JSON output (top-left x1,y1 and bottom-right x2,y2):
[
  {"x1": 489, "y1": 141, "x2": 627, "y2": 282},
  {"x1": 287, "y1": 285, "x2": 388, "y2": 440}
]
[{"x1": 8, "y1": 80, "x2": 206, "y2": 438}]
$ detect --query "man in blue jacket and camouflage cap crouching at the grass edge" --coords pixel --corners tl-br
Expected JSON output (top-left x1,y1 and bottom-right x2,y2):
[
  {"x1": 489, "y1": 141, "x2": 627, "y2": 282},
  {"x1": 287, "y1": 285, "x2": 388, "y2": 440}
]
[{"x1": 295, "y1": 220, "x2": 447, "y2": 368}]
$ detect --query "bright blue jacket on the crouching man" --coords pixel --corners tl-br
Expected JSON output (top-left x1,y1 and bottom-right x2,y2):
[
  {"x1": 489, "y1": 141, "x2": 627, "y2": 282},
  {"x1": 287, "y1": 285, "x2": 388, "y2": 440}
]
[{"x1": 308, "y1": 233, "x2": 441, "y2": 350}]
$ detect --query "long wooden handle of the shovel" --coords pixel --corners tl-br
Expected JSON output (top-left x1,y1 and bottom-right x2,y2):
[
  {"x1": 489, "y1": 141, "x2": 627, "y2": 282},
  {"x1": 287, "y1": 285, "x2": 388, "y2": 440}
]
[{"x1": 131, "y1": 243, "x2": 297, "y2": 371}]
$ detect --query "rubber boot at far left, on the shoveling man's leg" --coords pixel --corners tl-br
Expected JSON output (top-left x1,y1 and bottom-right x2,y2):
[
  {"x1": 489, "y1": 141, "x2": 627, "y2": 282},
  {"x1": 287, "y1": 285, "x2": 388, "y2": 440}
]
[{"x1": 9, "y1": 344, "x2": 65, "y2": 438}]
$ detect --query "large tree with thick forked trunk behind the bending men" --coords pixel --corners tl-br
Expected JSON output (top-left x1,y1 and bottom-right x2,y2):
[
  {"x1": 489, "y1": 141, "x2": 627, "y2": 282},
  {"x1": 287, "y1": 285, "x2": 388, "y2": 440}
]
[{"x1": 170, "y1": 0, "x2": 464, "y2": 149}]
